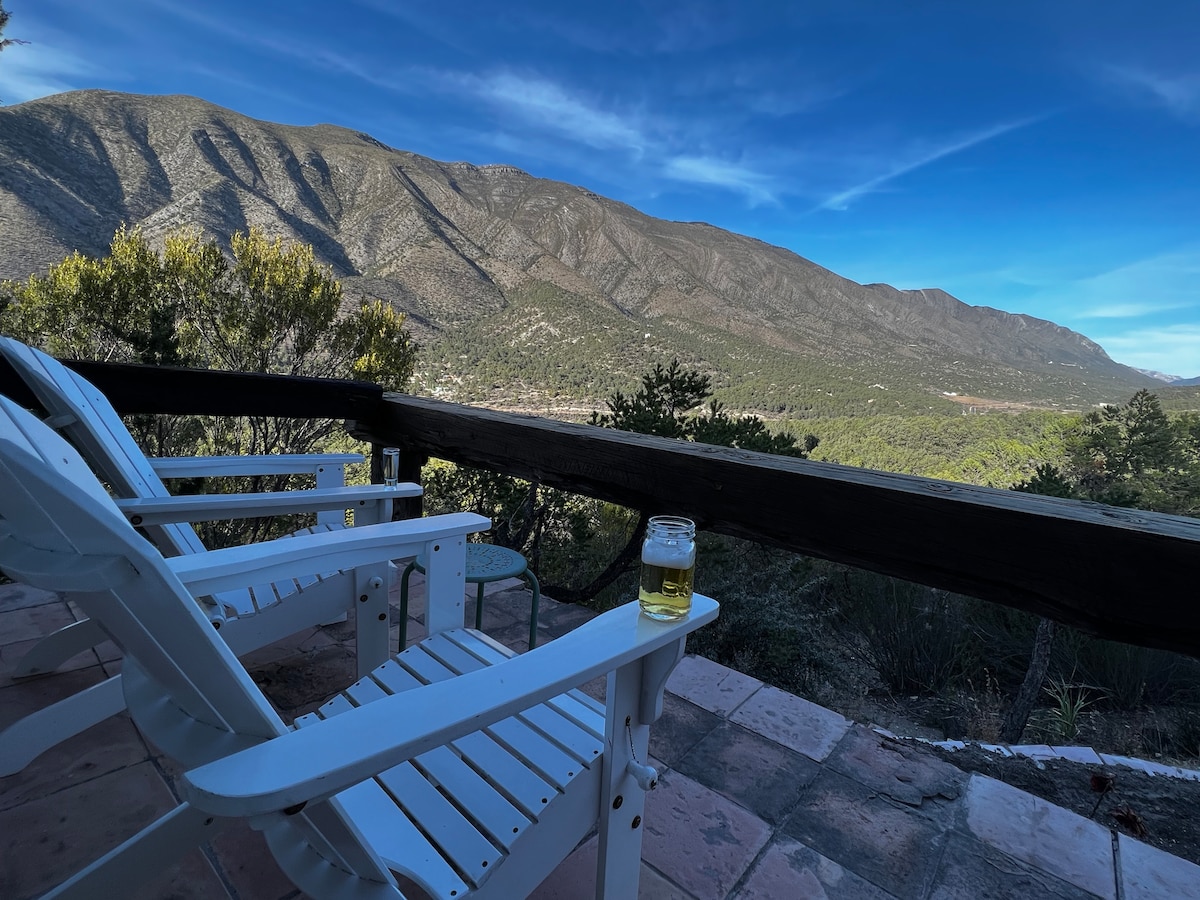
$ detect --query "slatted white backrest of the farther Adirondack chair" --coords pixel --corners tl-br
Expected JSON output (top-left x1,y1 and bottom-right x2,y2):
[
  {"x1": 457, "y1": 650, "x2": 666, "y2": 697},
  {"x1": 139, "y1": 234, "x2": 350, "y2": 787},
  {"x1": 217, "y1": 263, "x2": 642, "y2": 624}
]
[{"x1": 0, "y1": 337, "x2": 204, "y2": 557}]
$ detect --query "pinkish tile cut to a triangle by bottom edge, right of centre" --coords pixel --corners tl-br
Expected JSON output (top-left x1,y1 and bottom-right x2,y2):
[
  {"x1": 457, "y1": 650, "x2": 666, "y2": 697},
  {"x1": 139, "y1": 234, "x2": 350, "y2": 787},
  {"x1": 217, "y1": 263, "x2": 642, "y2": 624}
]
[{"x1": 737, "y1": 838, "x2": 894, "y2": 900}]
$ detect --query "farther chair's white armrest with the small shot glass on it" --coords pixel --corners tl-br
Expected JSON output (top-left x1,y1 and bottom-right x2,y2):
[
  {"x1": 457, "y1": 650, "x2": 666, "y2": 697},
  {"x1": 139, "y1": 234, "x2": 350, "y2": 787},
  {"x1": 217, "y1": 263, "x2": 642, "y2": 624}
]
[{"x1": 115, "y1": 482, "x2": 421, "y2": 526}]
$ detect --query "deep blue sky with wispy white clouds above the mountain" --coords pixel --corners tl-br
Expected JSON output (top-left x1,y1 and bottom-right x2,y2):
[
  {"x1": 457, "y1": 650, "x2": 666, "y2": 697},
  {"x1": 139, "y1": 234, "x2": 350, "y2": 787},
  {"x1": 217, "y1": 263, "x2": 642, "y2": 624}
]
[{"x1": 0, "y1": 0, "x2": 1200, "y2": 377}]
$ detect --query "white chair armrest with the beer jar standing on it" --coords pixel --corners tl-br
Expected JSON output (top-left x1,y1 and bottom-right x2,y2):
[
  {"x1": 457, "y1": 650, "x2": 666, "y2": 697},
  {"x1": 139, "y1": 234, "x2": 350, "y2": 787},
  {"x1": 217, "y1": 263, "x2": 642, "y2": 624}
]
[{"x1": 184, "y1": 594, "x2": 718, "y2": 816}]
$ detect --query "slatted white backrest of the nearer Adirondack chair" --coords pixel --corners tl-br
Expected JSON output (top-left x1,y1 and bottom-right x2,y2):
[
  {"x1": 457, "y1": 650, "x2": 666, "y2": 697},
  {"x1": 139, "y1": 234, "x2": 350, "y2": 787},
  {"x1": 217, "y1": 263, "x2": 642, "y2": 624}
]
[{"x1": 0, "y1": 397, "x2": 284, "y2": 738}]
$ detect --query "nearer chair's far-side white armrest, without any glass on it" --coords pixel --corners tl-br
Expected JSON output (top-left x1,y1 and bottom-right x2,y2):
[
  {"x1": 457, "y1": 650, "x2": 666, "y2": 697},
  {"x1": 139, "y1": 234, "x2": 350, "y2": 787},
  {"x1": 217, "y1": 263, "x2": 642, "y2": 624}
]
[{"x1": 164, "y1": 512, "x2": 492, "y2": 596}]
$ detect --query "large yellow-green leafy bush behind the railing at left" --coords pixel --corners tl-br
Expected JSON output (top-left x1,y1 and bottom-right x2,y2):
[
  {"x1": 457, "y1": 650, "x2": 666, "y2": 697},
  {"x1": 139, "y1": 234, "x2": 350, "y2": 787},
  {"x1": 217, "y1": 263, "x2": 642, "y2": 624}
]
[{"x1": 0, "y1": 227, "x2": 416, "y2": 544}]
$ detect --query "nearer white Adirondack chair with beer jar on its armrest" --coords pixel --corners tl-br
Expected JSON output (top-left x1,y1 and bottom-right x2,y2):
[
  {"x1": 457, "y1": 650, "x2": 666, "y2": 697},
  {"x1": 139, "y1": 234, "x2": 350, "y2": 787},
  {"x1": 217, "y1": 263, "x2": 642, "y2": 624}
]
[{"x1": 0, "y1": 398, "x2": 718, "y2": 900}]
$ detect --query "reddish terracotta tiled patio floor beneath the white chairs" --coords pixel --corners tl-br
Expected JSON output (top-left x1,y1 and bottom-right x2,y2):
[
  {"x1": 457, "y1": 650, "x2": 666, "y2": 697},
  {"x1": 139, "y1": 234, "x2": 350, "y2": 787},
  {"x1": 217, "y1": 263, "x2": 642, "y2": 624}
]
[{"x1": 0, "y1": 577, "x2": 1200, "y2": 900}]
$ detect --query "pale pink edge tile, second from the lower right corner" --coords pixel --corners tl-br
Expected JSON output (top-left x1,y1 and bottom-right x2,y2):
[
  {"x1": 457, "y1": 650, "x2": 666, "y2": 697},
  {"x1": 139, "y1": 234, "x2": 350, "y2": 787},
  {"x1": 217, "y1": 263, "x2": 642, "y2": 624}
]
[{"x1": 966, "y1": 777, "x2": 1116, "y2": 899}]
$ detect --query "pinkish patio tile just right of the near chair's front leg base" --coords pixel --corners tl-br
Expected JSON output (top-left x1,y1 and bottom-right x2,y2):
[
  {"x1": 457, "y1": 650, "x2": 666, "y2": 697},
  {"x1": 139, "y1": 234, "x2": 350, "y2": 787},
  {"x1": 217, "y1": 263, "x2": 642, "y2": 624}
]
[{"x1": 642, "y1": 772, "x2": 770, "y2": 900}]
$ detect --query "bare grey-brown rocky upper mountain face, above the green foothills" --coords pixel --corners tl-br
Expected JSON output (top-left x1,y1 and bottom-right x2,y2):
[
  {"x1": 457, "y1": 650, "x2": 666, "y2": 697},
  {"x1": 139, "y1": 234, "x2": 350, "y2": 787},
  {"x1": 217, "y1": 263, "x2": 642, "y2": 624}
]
[{"x1": 0, "y1": 91, "x2": 1148, "y2": 408}]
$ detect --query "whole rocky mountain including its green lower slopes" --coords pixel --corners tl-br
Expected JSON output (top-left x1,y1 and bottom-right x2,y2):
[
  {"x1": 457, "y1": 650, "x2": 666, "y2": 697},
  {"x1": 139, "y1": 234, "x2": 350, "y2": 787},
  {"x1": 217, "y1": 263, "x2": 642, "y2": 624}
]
[{"x1": 0, "y1": 91, "x2": 1156, "y2": 413}]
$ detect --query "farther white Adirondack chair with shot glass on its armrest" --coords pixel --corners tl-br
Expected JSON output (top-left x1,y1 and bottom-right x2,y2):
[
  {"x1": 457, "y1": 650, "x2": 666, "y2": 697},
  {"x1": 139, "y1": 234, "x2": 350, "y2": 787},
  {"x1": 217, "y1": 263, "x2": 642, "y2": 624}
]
[{"x1": 0, "y1": 337, "x2": 421, "y2": 775}]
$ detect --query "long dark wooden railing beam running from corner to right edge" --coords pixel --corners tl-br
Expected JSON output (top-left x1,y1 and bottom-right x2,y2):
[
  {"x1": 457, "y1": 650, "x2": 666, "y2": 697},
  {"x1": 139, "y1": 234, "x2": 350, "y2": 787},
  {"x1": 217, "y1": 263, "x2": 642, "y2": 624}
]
[{"x1": 353, "y1": 394, "x2": 1200, "y2": 656}]
